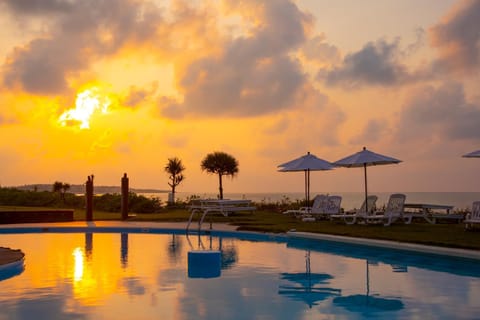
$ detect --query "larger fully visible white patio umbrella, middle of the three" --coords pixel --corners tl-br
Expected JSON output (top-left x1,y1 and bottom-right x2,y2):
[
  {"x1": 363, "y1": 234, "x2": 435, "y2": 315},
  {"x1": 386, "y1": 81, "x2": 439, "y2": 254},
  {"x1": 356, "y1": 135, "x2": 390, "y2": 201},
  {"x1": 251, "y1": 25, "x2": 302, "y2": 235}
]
[{"x1": 333, "y1": 147, "x2": 402, "y2": 212}]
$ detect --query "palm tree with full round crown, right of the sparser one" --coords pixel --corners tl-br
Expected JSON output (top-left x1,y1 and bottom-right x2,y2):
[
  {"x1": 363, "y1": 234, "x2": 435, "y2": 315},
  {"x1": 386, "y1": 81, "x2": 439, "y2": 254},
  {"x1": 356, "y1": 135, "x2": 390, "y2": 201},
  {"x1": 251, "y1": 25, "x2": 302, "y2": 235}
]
[{"x1": 201, "y1": 151, "x2": 238, "y2": 199}]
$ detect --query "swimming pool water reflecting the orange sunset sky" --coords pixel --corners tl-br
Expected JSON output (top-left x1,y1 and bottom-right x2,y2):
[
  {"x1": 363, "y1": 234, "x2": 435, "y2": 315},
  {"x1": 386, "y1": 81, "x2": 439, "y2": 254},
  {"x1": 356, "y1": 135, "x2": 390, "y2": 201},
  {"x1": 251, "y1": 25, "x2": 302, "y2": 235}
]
[{"x1": 0, "y1": 232, "x2": 480, "y2": 319}]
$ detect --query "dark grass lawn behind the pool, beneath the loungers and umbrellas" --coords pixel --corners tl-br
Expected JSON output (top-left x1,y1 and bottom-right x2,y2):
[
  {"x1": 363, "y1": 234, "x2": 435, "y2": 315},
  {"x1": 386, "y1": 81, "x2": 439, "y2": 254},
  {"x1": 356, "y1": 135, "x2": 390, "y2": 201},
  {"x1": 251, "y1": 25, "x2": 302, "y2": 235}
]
[{"x1": 0, "y1": 206, "x2": 480, "y2": 250}]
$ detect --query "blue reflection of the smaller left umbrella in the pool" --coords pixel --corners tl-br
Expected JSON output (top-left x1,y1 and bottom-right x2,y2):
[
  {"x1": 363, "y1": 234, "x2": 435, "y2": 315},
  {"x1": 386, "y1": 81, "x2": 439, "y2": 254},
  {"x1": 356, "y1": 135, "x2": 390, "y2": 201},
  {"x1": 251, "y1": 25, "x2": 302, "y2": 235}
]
[{"x1": 278, "y1": 251, "x2": 341, "y2": 308}]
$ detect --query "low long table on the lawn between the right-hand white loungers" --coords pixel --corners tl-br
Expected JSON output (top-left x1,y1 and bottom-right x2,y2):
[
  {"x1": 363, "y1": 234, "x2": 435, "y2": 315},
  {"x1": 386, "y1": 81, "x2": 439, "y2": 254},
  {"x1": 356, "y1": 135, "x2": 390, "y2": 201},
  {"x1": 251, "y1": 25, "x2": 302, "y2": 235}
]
[{"x1": 403, "y1": 203, "x2": 464, "y2": 224}]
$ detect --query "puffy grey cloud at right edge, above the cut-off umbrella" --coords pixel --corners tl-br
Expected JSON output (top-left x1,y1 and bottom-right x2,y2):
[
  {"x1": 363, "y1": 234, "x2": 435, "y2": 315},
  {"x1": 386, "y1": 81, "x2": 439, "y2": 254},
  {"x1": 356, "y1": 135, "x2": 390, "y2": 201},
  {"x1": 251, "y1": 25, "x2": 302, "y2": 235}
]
[{"x1": 398, "y1": 82, "x2": 480, "y2": 141}]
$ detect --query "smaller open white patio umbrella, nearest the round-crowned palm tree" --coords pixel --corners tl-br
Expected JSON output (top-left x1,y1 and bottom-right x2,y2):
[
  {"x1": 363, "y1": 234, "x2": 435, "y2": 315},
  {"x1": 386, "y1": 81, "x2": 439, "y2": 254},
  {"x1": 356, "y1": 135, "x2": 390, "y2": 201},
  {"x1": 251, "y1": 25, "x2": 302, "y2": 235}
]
[{"x1": 278, "y1": 152, "x2": 335, "y2": 206}]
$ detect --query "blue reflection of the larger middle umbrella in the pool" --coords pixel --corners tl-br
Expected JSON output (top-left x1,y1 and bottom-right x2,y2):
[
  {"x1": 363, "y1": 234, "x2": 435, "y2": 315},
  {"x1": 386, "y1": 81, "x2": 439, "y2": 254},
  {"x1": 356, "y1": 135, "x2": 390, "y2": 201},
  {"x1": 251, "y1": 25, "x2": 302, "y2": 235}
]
[{"x1": 333, "y1": 260, "x2": 404, "y2": 313}]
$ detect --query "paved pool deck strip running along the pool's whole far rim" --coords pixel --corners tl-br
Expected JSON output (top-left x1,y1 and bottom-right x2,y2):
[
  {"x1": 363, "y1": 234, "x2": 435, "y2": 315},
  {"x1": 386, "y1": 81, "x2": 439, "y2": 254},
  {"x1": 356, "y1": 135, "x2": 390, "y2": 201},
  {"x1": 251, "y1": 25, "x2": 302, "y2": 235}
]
[{"x1": 0, "y1": 221, "x2": 480, "y2": 266}]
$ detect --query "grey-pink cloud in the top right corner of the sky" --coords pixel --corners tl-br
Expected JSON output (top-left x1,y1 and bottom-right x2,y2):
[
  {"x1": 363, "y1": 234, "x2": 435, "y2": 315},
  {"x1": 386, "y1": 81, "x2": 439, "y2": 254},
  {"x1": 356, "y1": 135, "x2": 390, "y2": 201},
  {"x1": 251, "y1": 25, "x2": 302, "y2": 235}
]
[{"x1": 430, "y1": 0, "x2": 480, "y2": 73}]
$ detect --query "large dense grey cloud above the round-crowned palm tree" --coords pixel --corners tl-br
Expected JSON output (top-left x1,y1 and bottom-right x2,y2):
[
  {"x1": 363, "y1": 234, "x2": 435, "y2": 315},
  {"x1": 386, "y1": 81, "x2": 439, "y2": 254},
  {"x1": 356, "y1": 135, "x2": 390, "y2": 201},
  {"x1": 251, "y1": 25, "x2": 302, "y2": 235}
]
[{"x1": 181, "y1": 55, "x2": 305, "y2": 116}]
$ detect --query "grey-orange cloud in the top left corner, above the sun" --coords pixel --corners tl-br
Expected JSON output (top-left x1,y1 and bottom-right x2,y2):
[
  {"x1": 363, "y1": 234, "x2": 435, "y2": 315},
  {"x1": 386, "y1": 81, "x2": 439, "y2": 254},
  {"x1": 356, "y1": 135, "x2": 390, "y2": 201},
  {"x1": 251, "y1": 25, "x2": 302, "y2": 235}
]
[{"x1": 3, "y1": 0, "x2": 161, "y2": 94}]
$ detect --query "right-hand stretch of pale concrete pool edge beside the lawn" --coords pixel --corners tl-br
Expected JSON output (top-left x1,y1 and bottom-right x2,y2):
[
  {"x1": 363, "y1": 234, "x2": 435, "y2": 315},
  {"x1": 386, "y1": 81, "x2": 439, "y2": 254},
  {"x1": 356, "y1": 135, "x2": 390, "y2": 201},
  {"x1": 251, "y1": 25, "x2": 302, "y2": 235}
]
[{"x1": 287, "y1": 231, "x2": 480, "y2": 260}]
